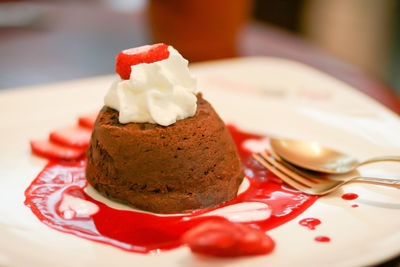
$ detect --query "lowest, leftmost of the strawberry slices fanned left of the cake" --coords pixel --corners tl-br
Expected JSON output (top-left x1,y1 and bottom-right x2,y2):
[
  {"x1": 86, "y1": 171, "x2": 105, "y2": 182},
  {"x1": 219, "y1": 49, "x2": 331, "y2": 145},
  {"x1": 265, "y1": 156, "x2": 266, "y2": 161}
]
[{"x1": 31, "y1": 140, "x2": 85, "y2": 160}]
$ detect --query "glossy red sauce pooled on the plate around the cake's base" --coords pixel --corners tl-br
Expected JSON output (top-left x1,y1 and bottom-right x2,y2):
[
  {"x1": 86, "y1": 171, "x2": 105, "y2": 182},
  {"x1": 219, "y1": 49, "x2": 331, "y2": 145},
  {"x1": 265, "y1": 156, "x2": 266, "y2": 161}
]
[{"x1": 25, "y1": 126, "x2": 317, "y2": 253}]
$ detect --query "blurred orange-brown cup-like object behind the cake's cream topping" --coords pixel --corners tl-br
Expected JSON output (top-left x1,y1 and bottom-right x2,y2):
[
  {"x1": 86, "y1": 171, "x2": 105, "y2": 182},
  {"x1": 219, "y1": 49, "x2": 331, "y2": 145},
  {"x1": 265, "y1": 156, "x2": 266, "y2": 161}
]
[{"x1": 148, "y1": 0, "x2": 252, "y2": 62}]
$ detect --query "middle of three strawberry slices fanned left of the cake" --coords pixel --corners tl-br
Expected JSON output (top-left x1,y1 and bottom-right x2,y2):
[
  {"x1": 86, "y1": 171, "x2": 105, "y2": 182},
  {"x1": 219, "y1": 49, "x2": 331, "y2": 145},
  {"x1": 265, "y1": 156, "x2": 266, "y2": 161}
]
[{"x1": 50, "y1": 126, "x2": 92, "y2": 148}]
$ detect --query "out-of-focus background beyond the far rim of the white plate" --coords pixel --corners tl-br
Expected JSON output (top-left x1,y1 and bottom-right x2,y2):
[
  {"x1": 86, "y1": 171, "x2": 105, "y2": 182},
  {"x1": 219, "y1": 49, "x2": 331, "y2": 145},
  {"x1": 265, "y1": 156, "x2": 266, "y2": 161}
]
[{"x1": 0, "y1": 0, "x2": 400, "y2": 99}]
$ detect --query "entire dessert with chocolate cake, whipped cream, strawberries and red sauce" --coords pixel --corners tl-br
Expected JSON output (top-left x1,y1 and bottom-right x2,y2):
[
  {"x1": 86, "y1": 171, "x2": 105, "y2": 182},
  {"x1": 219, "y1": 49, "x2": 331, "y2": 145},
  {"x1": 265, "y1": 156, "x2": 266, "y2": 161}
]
[{"x1": 24, "y1": 44, "x2": 320, "y2": 257}]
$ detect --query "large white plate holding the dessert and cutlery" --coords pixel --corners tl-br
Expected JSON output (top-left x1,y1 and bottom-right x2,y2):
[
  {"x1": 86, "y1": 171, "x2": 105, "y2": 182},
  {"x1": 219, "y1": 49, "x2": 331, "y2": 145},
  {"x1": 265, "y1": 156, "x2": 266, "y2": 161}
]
[{"x1": 0, "y1": 58, "x2": 400, "y2": 266}]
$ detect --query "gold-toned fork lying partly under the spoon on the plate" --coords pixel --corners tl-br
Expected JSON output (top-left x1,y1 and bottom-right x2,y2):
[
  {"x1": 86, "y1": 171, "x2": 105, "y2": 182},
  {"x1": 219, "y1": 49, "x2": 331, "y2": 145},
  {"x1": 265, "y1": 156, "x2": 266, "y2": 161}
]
[{"x1": 253, "y1": 150, "x2": 400, "y2": 195}]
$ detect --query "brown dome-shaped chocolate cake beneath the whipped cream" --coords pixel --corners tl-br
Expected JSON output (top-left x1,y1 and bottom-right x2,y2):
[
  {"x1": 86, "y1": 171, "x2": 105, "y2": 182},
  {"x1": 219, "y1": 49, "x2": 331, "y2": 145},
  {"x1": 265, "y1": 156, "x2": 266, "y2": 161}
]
[{"x1": 86, "y1": 94, "x2": 244, "y2": 213}]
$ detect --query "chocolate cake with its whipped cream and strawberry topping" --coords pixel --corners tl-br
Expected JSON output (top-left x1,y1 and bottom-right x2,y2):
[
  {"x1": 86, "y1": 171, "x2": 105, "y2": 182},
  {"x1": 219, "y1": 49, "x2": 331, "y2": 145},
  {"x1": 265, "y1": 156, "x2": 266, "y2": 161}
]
[{"x1": 86, "y1": 44, "x2": 244, "y2": 216}]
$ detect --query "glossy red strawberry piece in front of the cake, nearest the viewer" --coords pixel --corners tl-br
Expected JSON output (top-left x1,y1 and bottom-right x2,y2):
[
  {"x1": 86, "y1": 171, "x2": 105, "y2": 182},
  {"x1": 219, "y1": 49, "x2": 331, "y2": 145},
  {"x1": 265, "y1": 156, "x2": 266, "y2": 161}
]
[{"x1": 182, "y1": 220, "x2": 275, "y2": 257}]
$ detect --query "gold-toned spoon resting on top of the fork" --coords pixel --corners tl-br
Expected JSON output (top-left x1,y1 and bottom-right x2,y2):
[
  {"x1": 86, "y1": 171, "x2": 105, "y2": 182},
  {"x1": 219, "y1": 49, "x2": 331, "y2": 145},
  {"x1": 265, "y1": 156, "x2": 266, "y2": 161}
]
[{"x1": 270, "y1": 138, "x2": 400, "y2": 173}]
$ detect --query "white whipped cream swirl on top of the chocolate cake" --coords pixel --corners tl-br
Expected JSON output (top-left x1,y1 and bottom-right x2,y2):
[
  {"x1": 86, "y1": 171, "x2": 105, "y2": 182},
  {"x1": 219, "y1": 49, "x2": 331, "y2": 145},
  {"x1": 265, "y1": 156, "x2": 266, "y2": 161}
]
[{"x1": 104, "y1": 46, "x2": 197, "y2": 126}]
